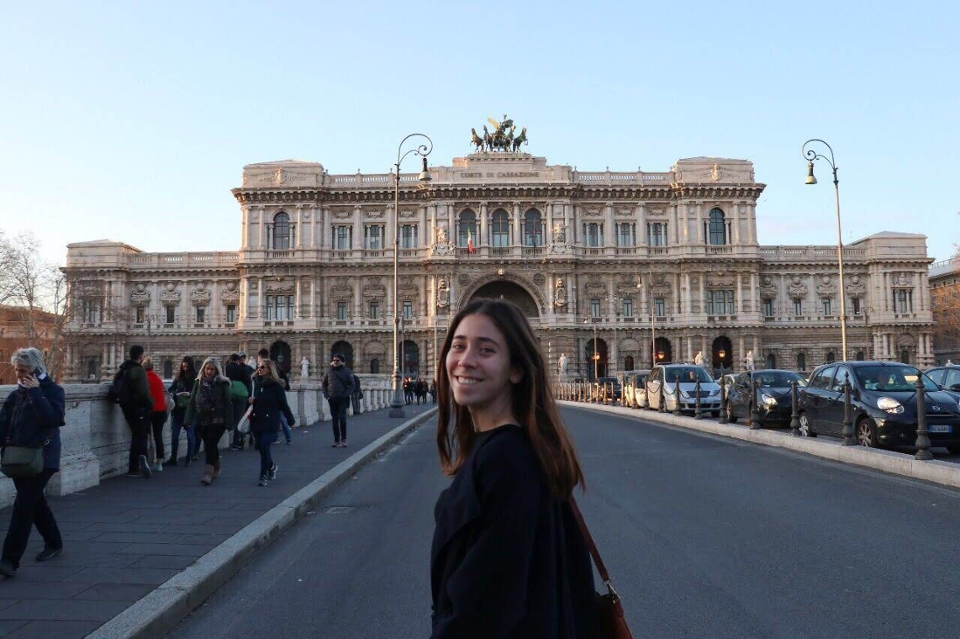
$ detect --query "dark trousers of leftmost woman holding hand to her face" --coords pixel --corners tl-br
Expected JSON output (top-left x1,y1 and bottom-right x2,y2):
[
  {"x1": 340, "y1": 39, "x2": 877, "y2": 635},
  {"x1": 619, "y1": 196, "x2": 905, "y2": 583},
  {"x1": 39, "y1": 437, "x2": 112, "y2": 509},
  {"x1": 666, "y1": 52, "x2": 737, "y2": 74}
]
[{"x1": 3, "y1": 470, "x2": 63, "y2": 568}]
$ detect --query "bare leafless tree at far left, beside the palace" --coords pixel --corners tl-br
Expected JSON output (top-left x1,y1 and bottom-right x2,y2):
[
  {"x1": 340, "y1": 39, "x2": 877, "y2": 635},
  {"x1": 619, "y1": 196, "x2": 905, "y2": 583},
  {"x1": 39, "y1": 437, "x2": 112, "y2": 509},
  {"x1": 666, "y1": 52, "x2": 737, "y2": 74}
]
[{"x1": 0, "y1": 230, "x2": 67, "y2": 378}]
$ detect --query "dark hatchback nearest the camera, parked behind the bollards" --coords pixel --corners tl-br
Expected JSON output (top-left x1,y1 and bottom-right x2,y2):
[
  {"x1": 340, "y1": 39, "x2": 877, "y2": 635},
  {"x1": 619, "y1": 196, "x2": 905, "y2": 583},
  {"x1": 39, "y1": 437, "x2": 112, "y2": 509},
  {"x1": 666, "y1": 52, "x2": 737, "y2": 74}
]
[{"x1": 800, "y1": 362, "x2": 960, "y2": 453}]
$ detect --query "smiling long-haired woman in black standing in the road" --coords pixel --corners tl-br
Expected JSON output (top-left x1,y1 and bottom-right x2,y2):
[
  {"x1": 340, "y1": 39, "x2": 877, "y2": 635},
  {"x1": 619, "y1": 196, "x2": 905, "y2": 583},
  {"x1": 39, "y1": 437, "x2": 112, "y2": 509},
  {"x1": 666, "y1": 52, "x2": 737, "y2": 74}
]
[{"x1": 430, "y1": 300, "x2": 597, "y2": 639}]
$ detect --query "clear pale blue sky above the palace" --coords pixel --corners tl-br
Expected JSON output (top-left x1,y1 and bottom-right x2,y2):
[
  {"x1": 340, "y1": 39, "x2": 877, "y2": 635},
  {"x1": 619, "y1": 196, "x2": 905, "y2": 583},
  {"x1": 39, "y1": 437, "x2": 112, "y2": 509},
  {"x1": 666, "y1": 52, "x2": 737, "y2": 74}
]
[{"x1": 0, "y1": 0, "x2": 960, "y2": 261}]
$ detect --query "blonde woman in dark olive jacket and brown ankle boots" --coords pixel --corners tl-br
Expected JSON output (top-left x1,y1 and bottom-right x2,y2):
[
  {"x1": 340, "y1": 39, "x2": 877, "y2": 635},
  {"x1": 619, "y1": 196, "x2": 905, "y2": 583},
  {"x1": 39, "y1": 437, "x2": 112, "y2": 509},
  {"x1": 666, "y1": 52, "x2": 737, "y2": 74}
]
[{"x1": 184, "y1": 357, "x2": 233, "y2": 486}]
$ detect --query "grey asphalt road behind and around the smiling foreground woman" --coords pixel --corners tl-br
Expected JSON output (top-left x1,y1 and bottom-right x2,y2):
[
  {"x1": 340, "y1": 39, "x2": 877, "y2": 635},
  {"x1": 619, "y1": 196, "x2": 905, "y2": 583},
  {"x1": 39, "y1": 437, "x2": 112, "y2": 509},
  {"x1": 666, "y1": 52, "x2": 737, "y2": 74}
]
[{"x1": 171, "y1": 409, "x2": 960, "y2": 639}]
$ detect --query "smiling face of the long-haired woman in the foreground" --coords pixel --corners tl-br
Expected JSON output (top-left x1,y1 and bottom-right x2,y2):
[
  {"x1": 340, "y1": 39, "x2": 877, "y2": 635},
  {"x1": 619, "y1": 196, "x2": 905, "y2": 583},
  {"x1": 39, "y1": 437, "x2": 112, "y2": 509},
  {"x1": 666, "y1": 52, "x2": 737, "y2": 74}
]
[{"x1": 446, "y1": 314, "x2": 520, "y2": 408}]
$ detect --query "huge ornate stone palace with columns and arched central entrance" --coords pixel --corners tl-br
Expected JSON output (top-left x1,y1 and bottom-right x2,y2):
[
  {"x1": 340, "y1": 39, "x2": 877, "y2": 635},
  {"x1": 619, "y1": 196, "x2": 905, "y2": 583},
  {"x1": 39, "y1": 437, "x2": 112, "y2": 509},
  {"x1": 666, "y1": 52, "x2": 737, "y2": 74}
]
[{"x1": 56, "y1": 138, "x2": 933, "y2": 380}]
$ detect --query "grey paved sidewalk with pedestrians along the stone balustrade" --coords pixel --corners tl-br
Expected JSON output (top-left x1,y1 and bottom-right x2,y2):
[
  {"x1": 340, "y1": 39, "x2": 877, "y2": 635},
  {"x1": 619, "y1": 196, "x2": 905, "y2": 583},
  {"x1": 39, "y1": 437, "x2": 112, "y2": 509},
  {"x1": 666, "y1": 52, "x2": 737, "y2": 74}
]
[{"x1": 0, "y1": 404, "x2": 433, "y2": 639}]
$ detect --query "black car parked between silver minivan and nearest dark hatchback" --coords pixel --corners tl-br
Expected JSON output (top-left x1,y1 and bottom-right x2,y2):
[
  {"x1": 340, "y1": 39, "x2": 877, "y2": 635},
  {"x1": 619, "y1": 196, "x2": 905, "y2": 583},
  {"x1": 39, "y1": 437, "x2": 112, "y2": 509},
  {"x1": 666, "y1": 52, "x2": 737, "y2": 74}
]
[{"x1": 727, "y1": 369, "x2": 807, "y2": 426}]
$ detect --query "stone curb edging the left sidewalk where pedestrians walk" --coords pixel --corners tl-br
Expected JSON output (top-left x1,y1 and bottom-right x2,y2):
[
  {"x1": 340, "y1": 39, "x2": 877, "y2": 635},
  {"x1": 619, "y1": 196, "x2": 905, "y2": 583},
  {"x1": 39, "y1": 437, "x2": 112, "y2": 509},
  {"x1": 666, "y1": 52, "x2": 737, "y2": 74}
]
[{"x1": 87, "y1": 408, "x2": 437, "y2": 639}]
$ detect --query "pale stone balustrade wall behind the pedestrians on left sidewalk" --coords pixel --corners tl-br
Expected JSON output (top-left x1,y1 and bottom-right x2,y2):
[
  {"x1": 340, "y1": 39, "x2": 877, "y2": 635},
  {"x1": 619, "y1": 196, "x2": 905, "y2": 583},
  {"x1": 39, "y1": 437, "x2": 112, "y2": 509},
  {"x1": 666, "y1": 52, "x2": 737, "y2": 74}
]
[{"x1": 0, "y1": 375, "x2": 392, "y2": 507}]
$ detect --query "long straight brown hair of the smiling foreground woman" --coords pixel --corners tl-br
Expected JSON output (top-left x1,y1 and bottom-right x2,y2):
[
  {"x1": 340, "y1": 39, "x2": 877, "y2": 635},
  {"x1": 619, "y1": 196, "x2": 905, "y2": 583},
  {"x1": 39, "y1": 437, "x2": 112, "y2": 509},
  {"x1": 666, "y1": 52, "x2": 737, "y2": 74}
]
[{"x1": 437, "y1": 299, "x2": 585, "y2": 499}]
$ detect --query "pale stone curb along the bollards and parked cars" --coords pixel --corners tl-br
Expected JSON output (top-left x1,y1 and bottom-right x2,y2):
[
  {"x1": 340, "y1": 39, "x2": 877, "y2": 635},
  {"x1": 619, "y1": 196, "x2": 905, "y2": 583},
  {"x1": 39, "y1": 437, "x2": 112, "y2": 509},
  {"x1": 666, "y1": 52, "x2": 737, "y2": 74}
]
[{"x1": 557, "y1": 400, "x2": 960, "y2": 488}]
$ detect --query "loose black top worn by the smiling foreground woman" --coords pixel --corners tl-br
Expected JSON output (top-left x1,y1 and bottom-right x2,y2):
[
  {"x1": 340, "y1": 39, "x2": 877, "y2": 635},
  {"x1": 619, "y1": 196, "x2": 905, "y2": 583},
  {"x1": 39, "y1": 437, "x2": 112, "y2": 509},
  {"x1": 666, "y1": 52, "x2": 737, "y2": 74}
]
[{"x1": 430, "y1": 426, "x2": 595, "y2": 639}]
